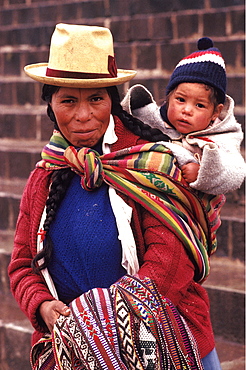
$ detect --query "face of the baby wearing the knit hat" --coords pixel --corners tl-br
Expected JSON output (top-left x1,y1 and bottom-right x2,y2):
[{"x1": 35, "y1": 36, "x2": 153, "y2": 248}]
[{"x1": 167, "y1": 82, "x2": 223, "y2": 134}]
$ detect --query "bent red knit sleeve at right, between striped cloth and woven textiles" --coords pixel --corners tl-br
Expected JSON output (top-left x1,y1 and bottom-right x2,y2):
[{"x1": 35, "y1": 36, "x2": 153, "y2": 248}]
[{"x1": 139, "y1": 210, "x2": 194, "y2": 305}]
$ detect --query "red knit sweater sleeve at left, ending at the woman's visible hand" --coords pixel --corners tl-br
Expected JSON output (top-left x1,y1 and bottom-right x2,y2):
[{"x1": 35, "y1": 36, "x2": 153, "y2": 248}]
[{"x1": 8, "y1": 172, "x2": 54, "y2": 331}]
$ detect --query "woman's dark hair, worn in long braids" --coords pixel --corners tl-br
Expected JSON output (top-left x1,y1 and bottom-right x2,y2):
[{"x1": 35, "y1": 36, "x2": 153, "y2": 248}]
[{"x1": 32, "y1": 85, "x2": 168, "y2": 272}]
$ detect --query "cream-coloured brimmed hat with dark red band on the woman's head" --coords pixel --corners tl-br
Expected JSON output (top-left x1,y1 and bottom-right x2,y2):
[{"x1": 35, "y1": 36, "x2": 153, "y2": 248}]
[{"x1": 24, "y1": 23, "x2": 137, "y2": 88}]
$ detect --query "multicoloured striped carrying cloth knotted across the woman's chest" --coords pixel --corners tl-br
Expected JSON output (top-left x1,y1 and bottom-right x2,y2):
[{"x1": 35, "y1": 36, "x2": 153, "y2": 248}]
[{"x1": 37, "y1": 131, "x2": 224, "y2": 282}]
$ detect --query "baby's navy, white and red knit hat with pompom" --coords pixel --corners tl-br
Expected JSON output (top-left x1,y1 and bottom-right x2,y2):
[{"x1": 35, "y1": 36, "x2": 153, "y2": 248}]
[{"x1": 166, "y1": 37, "x2": 226, "y2": 103}]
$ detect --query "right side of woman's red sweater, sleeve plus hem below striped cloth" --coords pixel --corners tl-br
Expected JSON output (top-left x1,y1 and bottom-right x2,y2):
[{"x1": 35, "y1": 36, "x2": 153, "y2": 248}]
[{"x1": 138, "y1": 209, "x2": 214, "y2": 357}]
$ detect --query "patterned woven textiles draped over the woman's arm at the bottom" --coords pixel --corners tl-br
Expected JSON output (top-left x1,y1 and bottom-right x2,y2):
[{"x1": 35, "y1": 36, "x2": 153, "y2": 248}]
[{"x1": 31, "y1": 275, "x2": 203, "y2": 370}]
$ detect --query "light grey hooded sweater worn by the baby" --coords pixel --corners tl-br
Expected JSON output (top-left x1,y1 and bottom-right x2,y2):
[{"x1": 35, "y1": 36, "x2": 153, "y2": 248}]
[{"x1": 122, "y1": 86, "x2": 246, "y2": 195}]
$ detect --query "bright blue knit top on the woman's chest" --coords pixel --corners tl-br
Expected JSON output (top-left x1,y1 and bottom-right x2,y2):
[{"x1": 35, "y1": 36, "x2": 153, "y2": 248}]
[{"x1": 48, "y1": 175, "x2": 126, "y2": 302}]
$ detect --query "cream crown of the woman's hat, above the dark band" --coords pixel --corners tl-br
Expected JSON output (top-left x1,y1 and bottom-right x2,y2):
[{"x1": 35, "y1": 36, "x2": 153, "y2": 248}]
[{"x1": 48, "y1": 24, "x2": 116, "y2": 77}]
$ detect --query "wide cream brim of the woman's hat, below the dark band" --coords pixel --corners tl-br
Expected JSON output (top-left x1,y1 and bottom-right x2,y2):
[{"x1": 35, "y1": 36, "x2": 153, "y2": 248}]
[{"x1": 24, "y1": 63, "x2": 137, "y2": 88}]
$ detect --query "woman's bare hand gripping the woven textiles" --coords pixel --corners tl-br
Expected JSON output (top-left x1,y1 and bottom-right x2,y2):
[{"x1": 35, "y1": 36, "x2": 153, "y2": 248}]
[{"x1": 39, "y1": 300, "x2": 70, "y2": 332}]
